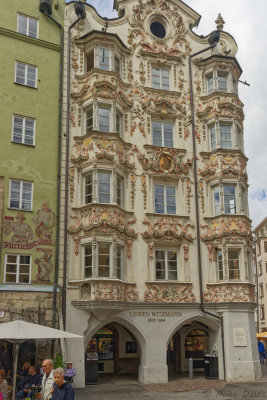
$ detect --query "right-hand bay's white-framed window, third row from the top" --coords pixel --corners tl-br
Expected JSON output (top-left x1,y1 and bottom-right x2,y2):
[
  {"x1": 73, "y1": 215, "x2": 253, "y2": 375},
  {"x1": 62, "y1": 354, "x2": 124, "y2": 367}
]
[{"x1": 213, "y1": 184, "x2": 236, "y2": 215}]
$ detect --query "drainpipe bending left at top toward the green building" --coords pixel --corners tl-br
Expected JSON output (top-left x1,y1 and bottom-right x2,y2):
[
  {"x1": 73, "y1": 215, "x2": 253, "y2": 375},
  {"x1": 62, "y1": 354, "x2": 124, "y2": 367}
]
[{"x1": 40, "y1": 11, "x2": 63, "y2": 355}]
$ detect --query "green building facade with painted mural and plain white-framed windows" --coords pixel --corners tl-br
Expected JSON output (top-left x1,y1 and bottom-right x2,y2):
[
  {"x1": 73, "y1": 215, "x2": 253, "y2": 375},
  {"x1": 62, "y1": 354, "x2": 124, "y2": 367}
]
[{"x1": 0, "y1": 0, "x2": 65, "y2": 350}]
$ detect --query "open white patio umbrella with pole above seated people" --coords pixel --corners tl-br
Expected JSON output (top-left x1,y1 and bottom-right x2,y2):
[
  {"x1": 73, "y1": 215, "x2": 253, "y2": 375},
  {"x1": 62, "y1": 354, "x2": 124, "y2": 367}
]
[{"x1": 0, "y1": 320, "x2": 83, "y2": 400}]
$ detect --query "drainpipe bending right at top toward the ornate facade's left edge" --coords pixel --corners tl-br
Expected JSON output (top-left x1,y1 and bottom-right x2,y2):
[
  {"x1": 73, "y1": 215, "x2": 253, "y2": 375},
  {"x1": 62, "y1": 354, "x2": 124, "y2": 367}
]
[{"x1": 62, "y1": 1, "x2": 86, "y2": 329}]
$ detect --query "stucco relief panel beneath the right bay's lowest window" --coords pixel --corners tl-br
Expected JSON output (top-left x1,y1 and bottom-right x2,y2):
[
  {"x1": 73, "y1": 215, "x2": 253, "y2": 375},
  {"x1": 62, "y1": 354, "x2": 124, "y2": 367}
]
[{"x1": 203, "y1": 284, "x2": 255, "y2": 303}]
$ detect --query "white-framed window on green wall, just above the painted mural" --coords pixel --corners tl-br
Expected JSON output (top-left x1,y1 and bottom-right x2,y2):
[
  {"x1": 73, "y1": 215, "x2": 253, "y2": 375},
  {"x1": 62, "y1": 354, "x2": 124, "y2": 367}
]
[{"x1": 9, "y1": 180, "x2": 33, "y2": 211}]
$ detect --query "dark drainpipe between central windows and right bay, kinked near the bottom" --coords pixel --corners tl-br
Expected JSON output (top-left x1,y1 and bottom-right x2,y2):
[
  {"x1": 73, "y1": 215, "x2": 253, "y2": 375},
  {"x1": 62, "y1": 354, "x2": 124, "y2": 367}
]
[{"x1": 188, "y1": 31, "x2": 226, "y2": 380}]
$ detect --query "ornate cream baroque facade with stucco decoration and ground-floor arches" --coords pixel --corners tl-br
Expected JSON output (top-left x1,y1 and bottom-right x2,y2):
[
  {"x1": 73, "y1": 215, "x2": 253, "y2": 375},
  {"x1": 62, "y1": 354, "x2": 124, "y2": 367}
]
[{"x1": 61, "y1": 0, "x2": 260, "y2": 386}]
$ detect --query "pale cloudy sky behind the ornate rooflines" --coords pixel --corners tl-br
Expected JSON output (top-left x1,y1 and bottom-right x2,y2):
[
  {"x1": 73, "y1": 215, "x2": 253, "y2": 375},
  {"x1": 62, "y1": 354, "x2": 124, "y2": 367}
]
[{"x1": 84, "y1": 0, "x2": 267, "y2": 228}]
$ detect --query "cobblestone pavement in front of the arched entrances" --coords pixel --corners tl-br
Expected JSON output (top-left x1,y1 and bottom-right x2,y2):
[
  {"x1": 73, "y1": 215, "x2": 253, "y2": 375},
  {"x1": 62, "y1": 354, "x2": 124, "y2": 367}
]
[{"x1": 75, "y1": 365, "x2": 267, "y2": 400}]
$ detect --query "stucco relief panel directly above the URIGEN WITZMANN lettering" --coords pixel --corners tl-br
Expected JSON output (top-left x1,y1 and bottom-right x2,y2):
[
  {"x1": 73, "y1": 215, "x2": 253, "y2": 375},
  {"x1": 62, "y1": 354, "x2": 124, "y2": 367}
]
[{"x1": 144, "y1": 284, "x2": 195, "y2": 303}]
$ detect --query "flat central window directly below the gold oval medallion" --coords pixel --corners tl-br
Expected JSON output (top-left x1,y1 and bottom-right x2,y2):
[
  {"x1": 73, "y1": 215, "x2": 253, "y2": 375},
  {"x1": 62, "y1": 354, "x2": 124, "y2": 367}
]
[{"x1": 154, "y1": 184, "x2": 176, "y2": 214}]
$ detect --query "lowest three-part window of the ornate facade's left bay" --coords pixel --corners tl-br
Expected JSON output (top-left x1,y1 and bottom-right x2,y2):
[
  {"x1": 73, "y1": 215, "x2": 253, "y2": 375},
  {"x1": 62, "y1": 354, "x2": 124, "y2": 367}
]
[{"x1": 83, "y1": 240, "x2": 123, "y2": 279}]
